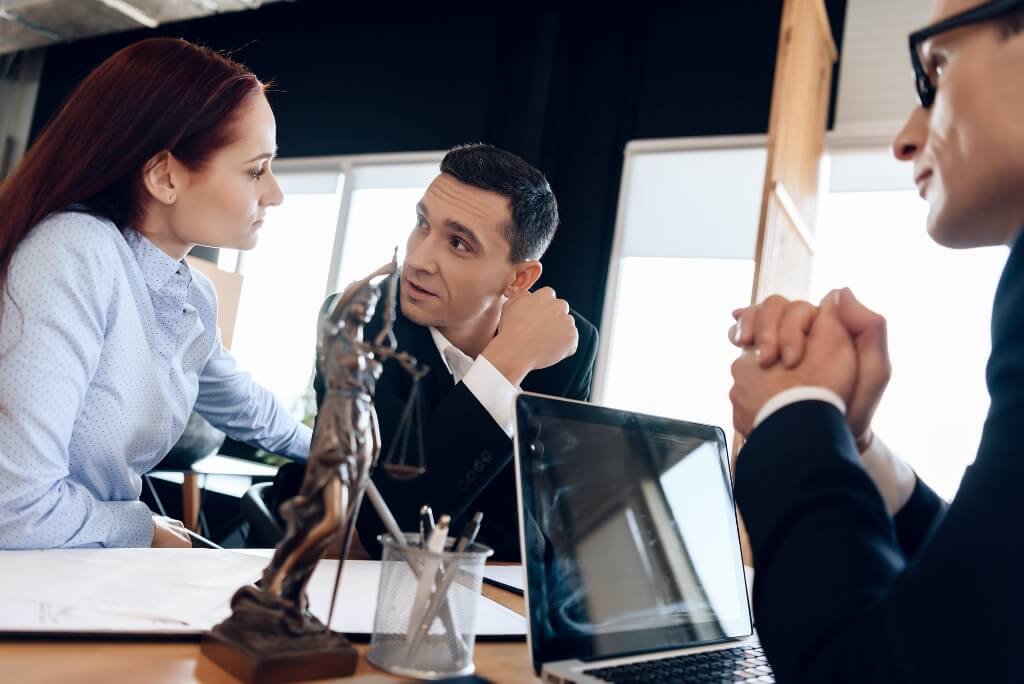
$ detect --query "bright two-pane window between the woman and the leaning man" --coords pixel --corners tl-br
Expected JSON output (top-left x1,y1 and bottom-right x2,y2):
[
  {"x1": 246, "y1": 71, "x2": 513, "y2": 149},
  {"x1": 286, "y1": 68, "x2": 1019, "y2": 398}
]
[{"x1": 218, "y1": 153, "x2": 442, "y2": 419}]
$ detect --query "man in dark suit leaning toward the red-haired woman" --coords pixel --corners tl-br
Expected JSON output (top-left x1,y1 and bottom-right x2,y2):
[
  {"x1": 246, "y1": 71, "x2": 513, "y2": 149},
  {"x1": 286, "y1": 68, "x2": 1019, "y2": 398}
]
[{"x1": 279, "y1": 144, "x2": 597, "y2": 560}]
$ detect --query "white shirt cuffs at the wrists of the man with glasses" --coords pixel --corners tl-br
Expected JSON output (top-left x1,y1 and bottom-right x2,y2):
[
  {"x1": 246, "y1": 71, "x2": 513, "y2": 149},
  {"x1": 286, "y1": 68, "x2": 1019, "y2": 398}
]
[{"x1": 754, "y1": 386, "x2": 918, "y2": 514}]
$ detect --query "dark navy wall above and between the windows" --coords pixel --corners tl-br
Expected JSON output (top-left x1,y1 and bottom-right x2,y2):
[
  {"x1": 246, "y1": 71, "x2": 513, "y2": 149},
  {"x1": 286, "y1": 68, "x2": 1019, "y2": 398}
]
[{"x1": 33, "y1": 0, "x2": 846, "y2": 331}]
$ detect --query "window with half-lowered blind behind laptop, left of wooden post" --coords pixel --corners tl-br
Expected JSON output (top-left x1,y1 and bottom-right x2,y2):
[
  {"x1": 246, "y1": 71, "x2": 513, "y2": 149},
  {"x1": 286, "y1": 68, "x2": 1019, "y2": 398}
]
[{"x1": 595, "y1": 136, "x2": 766, "y2": 454}]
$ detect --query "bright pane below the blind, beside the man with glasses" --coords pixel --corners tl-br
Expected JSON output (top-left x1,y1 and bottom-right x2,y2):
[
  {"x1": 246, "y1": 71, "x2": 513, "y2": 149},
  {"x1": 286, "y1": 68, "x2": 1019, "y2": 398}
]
[{"x1": 813, "y1": 189, "x2": 1007, "y2": 498}]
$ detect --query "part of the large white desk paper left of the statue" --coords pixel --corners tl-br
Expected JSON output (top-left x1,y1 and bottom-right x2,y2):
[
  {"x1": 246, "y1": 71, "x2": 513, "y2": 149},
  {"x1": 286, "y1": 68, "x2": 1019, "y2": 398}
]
[{"x1": 0, "y1": 549, "x2": 266, "y2": 634}]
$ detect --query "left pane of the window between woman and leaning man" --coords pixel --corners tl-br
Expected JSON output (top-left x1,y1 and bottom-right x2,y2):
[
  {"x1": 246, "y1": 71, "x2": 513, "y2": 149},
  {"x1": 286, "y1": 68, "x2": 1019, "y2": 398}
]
[{"x1": 232, "y1": 172, "x2": 341, "y2": 419}]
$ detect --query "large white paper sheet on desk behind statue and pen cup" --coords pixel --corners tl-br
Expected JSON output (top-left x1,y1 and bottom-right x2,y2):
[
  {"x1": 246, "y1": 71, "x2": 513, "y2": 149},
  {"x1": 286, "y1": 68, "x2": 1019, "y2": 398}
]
[{"x1": 0, "y1": 549, "x2": 525, "y2": 638}]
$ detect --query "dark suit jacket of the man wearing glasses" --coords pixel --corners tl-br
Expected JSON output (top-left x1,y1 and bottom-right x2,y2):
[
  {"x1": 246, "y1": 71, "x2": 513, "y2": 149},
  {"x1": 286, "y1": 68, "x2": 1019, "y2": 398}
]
[{"x1": 736, "y1": 233, "x2": 1024, "y2": 683}]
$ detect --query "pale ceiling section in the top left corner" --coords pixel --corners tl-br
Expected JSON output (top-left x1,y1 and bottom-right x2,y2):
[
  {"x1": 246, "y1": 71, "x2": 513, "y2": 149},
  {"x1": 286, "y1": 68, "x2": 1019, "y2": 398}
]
[{"x1": 0, "y1": 0, "x2": 292, "y2": 54}]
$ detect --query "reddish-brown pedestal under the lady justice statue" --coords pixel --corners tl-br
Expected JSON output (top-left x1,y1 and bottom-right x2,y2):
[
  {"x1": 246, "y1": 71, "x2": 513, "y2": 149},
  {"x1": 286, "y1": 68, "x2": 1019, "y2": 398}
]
[{"x1": 200, "y1": 632, "x2": 359, "y2": 684}]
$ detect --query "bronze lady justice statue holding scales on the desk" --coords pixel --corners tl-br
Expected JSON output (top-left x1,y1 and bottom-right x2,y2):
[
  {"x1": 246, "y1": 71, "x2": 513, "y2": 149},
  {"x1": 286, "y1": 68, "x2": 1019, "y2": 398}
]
[{"x1": 203, "y1": 259, "x2": 426, "y2": 681}]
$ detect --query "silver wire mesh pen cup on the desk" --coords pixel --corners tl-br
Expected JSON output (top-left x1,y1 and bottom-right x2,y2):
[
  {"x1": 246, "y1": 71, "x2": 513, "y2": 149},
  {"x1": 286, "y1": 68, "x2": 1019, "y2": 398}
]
[{"x1": 367, "y1": 535, "x2": 494, "y2": 679}]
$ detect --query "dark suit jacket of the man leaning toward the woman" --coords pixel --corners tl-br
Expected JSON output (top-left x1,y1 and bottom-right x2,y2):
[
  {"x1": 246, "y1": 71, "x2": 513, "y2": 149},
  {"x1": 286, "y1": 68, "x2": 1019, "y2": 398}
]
[{"x1": 313, "y1": 278, "x2": 597, "y2": 560}]
